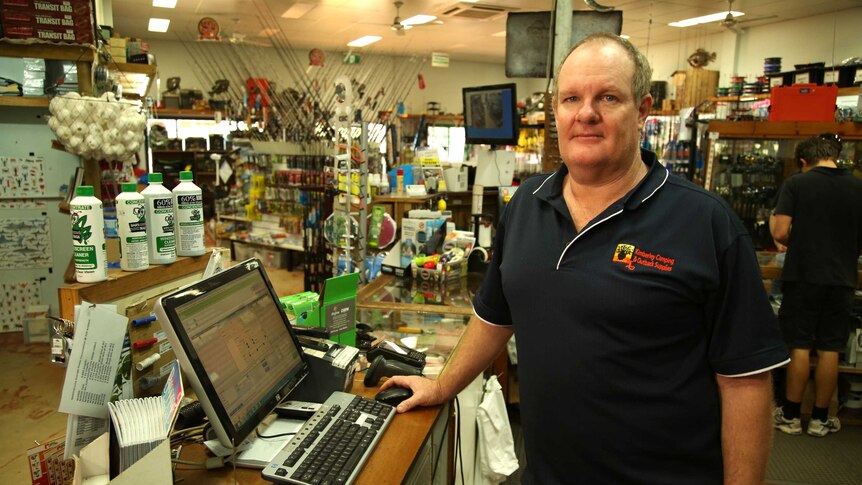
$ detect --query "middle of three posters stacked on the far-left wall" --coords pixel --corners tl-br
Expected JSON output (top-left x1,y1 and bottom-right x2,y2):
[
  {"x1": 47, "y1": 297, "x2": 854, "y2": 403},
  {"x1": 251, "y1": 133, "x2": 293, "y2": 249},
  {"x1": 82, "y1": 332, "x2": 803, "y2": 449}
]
[{"x1": 0, "y1": 217, "x2": 54, "y2": 269}]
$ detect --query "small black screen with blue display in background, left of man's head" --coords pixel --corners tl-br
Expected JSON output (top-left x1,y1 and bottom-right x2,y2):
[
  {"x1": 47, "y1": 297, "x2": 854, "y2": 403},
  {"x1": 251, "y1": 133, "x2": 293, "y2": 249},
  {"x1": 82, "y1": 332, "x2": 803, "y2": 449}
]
[{"x1": 462, "y1": 83, "x2": 520, "y2": 146}]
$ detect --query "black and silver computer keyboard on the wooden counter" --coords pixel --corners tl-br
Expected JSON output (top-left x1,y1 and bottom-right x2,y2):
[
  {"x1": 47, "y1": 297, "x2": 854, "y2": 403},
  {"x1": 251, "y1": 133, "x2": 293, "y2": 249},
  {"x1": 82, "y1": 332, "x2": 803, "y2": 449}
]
[{"x1": 261, "y1": 391, "x2": 395, "y2": 485}]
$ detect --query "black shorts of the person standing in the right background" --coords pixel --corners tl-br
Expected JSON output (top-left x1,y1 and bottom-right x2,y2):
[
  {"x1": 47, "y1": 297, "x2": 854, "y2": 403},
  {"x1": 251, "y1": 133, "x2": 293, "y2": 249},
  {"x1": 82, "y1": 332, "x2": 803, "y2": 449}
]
[{"x1": 778, "y1": 281, "x2": 854, "y2": 351}]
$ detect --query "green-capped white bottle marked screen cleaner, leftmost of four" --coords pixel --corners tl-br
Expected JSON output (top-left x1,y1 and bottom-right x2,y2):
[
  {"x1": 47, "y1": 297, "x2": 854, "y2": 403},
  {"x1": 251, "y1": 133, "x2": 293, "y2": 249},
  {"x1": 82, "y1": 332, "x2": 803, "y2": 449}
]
[{"x1": 69, "y1": 185, "x2": 108, "y2": 283}]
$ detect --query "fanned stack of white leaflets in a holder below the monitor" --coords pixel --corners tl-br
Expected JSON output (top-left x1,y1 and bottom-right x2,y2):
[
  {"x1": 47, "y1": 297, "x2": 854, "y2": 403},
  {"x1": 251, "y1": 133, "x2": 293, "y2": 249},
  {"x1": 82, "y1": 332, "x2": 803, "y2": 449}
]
[{"x1": 108, "y1": 361, "x2": 183, "y2": 477}]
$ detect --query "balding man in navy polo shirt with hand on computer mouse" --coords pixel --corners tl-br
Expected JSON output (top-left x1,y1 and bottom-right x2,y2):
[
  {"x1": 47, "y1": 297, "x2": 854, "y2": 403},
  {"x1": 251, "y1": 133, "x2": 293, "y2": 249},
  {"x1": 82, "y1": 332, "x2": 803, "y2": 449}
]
[{"x1": 383, "y1": 34, "x2": 788, "y2": 485}]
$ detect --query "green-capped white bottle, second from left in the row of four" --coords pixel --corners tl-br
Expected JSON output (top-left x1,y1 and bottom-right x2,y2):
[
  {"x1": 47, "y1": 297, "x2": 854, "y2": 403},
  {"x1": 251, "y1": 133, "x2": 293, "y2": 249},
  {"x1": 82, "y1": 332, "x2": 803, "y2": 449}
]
[{"x1": 114, "y1": 182, "x2": 150, "y2": 271}]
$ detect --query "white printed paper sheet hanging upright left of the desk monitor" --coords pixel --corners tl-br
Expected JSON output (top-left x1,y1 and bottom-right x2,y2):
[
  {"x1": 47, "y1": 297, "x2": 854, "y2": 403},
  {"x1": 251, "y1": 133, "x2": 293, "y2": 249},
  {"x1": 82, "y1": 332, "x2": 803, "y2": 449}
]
[{"x1": 59, "y1": 302, "x2": 129, "y2": 418}]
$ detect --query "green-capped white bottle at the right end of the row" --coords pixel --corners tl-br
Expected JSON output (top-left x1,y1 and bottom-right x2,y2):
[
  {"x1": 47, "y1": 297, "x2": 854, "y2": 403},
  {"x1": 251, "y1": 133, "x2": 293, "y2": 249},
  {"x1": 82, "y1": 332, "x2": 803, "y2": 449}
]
[{"x1": 173, "y1": 171, "x2": 206, "y2": 256}]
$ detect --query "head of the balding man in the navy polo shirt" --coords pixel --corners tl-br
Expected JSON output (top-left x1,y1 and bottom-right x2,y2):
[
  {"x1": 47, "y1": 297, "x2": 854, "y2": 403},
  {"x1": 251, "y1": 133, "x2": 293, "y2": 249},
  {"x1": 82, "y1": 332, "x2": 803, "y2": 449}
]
[{"x1": 554, "y1": 42, "x2": 652, "y2": 171}]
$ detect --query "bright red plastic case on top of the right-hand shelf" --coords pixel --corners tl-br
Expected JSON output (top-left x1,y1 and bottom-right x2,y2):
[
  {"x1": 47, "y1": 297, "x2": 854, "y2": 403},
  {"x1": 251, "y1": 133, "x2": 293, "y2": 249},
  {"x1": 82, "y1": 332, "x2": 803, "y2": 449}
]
[{"x1": 769, "y1": 84, "x2": 838, "y2": 121}]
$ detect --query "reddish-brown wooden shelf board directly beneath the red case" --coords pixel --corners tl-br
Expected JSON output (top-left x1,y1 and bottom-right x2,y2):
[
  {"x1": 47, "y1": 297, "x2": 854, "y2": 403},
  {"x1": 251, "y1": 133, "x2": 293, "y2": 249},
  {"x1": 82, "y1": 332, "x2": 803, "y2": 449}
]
[{"x1": 709, "y1": 121, "x2": 862, "y2": 140}]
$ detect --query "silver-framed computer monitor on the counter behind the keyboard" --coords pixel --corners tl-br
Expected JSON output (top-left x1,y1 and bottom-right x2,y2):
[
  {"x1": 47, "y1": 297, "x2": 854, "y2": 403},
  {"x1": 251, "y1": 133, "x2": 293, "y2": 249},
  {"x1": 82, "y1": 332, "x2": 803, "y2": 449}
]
[{"x1": 155, "y1": 259, "x2": 309, "y2": 448}]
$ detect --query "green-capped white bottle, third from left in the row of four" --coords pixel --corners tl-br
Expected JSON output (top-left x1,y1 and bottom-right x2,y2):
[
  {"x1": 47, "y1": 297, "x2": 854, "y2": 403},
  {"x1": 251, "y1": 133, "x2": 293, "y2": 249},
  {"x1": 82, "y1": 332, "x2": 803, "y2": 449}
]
[{"x1": 141, "y1": 173, "x2": 177, "y2": 264}]
